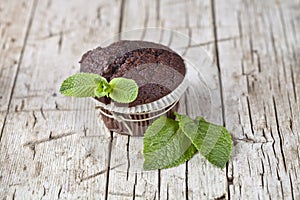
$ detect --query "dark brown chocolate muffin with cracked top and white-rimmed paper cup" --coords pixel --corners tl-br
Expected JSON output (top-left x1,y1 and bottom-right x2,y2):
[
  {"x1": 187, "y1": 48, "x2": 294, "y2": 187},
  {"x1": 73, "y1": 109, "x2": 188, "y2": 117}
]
[{"x1": 80, "y1": 40, "x2": 186, "y2": 135}]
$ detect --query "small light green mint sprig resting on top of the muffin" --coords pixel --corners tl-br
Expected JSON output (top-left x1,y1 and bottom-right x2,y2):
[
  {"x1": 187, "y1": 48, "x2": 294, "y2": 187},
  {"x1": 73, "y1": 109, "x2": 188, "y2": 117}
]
[{"x1": 59, "y1": 73, "x2": 138, "y2": 103}]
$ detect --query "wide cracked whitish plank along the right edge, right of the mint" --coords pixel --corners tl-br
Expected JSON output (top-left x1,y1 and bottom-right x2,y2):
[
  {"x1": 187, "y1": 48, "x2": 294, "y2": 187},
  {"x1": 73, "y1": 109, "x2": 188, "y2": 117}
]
[{"x1": 214, "y1": 1, "x2": 300, "y2": 199}]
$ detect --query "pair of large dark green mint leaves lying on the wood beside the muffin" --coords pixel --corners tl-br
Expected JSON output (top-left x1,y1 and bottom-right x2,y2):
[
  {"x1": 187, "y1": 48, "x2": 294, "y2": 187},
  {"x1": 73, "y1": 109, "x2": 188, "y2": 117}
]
[{"x1": 143, "y1": 113, "x2": 232, "y2": 170}]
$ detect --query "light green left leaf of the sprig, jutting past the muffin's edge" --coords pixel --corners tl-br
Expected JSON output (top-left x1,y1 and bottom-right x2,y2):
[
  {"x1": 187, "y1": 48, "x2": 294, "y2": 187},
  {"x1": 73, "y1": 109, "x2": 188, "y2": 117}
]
[{"x1": 59, "y1": 73, "x2": 102, "y2": 97}]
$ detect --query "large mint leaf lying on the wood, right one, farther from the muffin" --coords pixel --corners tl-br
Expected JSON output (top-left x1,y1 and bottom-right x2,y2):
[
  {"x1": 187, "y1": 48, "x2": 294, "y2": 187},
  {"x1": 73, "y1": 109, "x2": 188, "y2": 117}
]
[{"x1": 176, "y1": 113, "x2": 232, "y2": 168}]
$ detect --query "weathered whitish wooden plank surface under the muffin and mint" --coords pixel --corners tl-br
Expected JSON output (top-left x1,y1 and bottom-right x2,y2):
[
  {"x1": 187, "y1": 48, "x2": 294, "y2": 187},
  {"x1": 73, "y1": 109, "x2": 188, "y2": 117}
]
[{"x1": 0, "y1": 0, "x2": 300, "y2": 199}]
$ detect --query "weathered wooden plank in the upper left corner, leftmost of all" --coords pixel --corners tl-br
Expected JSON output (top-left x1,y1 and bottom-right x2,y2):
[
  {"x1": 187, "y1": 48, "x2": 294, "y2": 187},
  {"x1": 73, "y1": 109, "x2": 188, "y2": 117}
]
[{"x1": 0, "y1": 1, "x2": 34, "y2": 141}]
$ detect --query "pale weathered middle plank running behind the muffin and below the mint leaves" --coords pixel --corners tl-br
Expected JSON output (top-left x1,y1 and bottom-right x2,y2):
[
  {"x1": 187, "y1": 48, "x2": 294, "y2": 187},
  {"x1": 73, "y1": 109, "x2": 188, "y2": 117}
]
[{"x1": 108, "y1": 0, "x2": 227, "y2": 199}]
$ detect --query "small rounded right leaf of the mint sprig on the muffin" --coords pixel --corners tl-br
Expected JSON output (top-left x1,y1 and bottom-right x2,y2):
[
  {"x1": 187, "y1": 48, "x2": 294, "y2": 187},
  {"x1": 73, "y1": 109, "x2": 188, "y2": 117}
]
[{"x1": 109, "y1": 78, "x2": 138, "y2": 103}]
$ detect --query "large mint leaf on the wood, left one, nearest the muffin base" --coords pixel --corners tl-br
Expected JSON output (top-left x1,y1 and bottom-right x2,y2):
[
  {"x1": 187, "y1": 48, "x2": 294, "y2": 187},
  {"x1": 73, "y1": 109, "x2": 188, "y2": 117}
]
[{"x1": 143, "y1": 116, "x2": 197, "y2": 170}]
